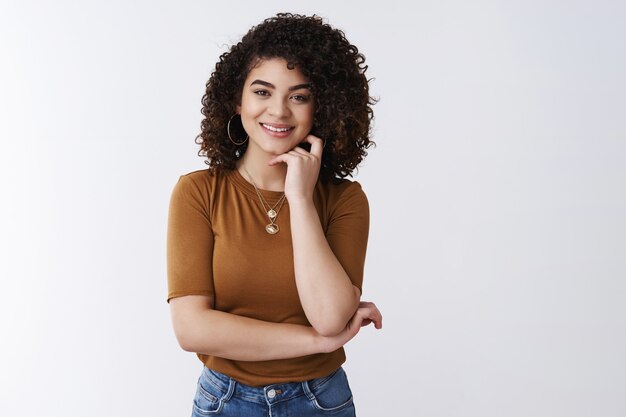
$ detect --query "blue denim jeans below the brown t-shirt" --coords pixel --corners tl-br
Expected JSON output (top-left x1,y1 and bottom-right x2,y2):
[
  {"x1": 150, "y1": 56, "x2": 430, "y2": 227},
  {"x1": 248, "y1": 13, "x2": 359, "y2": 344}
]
[{"x1": 192, "y1": 367, "x2": 356, "y2": 417}]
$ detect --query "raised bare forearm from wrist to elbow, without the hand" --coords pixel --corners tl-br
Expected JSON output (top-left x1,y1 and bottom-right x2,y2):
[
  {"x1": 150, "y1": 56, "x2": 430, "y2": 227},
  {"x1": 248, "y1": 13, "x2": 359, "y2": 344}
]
[{"x1": 289, "y1": 199, "x2": 361, "y2": 336}]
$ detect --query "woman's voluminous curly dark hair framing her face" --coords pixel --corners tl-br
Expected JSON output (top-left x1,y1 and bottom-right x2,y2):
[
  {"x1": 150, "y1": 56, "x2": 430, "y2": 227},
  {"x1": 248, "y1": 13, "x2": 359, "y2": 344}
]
[{"x1": 196, "y1": 13, "x2": 376, "y2": 181}]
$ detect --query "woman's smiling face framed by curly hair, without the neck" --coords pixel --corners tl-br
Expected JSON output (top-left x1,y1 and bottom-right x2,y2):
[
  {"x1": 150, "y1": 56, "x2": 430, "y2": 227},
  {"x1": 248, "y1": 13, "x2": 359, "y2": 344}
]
[{"x1": 237, "y1": 58, "x2": 315, "y2": 155}]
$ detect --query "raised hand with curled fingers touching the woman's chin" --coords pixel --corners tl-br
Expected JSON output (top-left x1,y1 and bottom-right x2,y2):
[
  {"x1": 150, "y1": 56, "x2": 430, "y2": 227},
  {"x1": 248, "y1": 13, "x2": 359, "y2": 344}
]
[{"x1": 268, "y1": 135, "x2": 324, "y2": 203}]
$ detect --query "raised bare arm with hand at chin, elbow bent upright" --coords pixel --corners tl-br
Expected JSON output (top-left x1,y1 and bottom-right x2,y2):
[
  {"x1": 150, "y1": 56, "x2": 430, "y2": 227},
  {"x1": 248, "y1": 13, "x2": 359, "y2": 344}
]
[{"x1": 269, "y1": 135, "x2": 367, "y2": 336}]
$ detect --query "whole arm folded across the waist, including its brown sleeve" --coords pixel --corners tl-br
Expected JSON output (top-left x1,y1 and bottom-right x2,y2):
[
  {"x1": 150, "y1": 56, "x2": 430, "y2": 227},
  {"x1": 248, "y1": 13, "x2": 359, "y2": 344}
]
[{"x1": 167, "y1": 175, "x2": 380, "y2": 361}]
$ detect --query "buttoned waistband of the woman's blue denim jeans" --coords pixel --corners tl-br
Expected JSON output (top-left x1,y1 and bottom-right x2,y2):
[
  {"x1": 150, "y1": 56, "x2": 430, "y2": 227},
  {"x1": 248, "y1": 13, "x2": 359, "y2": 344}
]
[{"x1": 202, "y1": 366, "x2": 343, "y2": 404}]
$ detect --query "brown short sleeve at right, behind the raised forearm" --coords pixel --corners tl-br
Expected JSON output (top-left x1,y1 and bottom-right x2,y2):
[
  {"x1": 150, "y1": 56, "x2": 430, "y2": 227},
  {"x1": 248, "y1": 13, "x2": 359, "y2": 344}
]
[{"x1": 326, "y1": 181, "x2": 369, "y2": 292}]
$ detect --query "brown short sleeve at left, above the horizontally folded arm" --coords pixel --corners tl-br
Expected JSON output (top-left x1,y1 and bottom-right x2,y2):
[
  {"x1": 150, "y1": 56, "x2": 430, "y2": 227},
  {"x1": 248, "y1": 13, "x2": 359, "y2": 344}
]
[{"x1": 167, "y1": 175, "x2": 214, "y2": 302}]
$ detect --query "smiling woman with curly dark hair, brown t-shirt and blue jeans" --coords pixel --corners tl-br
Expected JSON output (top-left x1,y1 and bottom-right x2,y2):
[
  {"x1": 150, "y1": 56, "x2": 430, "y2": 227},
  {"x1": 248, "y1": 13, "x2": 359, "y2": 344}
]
[{"x1": 167, "y1": 14, "x2": 382, "y2": 417}]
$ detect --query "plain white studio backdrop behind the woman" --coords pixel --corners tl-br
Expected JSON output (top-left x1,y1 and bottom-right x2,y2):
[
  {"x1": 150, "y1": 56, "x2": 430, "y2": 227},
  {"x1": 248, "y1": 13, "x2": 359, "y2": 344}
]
[{"x1": 0, "y1": 0, "x2": 626, "y2": 417}]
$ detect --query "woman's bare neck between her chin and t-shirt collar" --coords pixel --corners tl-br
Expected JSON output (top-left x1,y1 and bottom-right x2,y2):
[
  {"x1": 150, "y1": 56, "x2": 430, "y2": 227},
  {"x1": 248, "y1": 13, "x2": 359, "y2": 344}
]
[{"x1": 237, "y1": 152, "x2": 287, "y2": 191}]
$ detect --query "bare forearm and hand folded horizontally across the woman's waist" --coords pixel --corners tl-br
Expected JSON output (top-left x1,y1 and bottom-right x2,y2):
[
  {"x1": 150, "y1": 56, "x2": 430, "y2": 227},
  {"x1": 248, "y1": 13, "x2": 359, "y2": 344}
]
[{"x1": 170, "y1": 295, "x2": 382, "y2": 361}]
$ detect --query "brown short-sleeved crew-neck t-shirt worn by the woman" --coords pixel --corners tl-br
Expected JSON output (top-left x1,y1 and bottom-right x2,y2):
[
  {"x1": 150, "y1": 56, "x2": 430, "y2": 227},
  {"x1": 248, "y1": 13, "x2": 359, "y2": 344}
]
[{"x1": 167, "y1": 170, "x2": 369, "y2": 386}]
